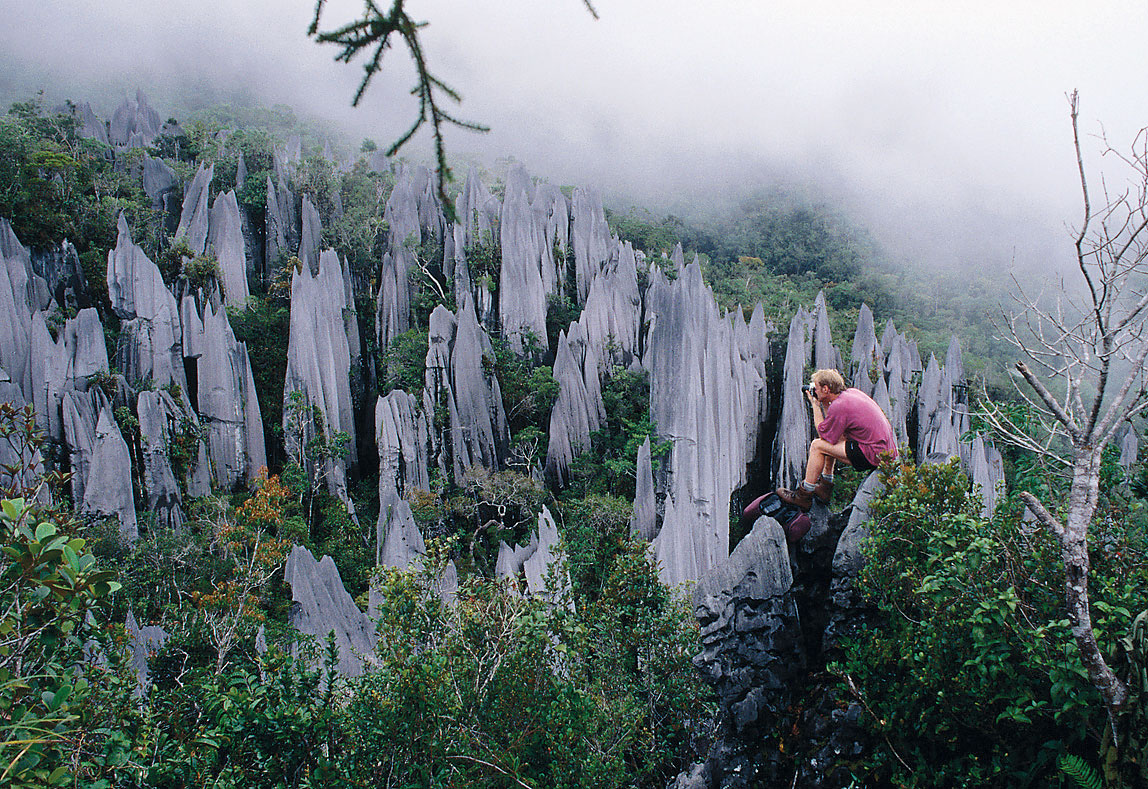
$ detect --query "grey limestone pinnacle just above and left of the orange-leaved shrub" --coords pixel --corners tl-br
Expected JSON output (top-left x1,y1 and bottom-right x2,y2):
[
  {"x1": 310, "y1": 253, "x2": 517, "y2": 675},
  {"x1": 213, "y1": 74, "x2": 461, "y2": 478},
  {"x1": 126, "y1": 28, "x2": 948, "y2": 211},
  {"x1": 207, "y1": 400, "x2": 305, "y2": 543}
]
[{"x1": 197, "y1": 304, "x2": 267, "y2": 490}]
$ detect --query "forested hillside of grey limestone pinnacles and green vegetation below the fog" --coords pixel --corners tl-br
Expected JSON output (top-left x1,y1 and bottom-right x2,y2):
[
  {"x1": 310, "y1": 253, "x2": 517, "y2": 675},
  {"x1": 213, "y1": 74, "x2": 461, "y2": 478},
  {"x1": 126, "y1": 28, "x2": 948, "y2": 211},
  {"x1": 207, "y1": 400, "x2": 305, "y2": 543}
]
[{"x1": 0, "y1": 94, "x2": 1148, "y2": 787}]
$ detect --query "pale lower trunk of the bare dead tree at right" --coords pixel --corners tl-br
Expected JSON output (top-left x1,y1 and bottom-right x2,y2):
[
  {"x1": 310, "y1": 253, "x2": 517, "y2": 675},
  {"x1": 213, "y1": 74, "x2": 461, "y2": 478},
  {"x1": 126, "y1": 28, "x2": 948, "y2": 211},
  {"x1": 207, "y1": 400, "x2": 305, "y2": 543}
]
[{"x1": 1061, "y1": 447, "x2": 1128, "y2": 720}]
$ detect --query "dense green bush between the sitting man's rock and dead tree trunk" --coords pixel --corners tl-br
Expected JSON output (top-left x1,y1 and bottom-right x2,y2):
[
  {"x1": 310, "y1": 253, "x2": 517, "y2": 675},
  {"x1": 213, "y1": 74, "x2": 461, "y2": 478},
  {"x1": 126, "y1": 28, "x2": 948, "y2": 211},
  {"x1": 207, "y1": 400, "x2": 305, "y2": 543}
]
[{"x1": 837, "y1": 462, "x2": 1148, "y2": 787}]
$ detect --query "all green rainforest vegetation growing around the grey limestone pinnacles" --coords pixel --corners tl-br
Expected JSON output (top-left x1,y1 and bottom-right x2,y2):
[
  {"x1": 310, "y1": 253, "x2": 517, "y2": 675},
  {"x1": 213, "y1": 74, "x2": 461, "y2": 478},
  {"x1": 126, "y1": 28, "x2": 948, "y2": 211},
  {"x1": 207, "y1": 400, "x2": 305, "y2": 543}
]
[{"x1": 0, "y1": 94, "x2": 1148, "y2": 788}]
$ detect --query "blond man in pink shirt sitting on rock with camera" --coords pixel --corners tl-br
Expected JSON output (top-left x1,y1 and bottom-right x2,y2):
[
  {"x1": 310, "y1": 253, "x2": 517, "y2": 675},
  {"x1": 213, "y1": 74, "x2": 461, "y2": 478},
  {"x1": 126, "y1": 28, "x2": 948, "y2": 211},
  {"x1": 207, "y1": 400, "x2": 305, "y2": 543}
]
[{"x1": 777, "y1": 370, "x2": 897, "y2": 510}]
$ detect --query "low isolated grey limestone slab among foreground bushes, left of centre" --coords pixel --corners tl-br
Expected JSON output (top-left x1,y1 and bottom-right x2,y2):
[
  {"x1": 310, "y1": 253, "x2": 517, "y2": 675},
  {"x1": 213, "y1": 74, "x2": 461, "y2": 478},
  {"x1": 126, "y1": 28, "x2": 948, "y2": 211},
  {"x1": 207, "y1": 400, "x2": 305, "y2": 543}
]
[{"x1": 284, "y1": 546, "x2": 375, "y2": 676}]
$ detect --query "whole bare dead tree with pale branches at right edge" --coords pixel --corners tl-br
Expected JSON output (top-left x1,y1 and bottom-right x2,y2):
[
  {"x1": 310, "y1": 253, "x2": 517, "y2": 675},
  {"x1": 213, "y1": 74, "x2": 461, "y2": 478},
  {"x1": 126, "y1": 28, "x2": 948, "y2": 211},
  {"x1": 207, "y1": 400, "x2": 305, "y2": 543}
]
[{"x1": 987, "y1": 92, "x2": 1148, "y2": 735}]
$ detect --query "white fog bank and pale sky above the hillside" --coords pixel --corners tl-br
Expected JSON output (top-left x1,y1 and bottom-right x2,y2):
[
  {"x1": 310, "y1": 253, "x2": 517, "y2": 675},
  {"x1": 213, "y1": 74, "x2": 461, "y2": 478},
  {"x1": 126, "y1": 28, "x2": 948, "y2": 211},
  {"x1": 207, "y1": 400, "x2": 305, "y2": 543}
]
[{"x1": 0, "y1": 0, "x2": 1148, "y2": 270}]
